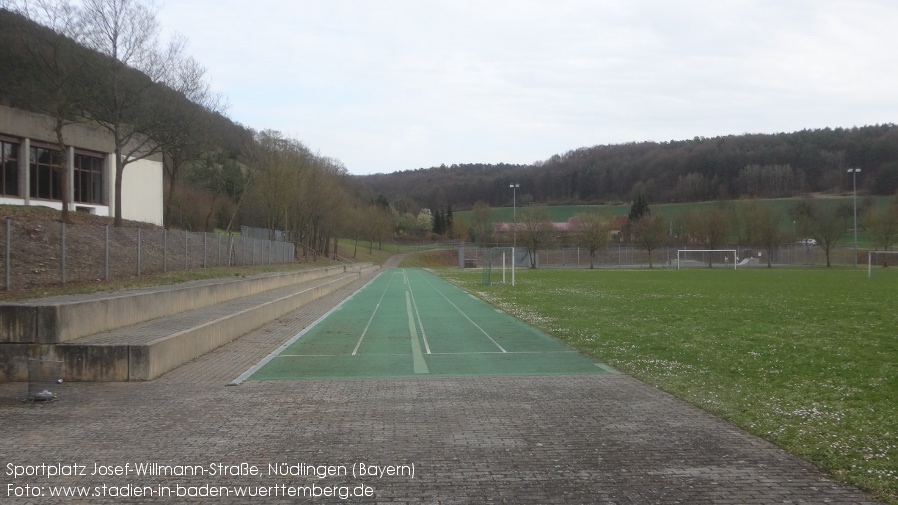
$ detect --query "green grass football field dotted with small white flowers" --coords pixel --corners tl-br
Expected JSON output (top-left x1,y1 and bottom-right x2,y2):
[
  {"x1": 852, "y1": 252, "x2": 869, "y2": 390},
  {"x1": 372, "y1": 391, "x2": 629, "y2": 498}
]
[{"x1": 439, "y1": 268, "x2": 898, "y2": 503}]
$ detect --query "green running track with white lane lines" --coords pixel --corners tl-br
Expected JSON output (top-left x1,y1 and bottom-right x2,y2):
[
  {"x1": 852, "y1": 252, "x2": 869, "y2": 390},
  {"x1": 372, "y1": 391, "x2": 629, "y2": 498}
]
[{"x1": 237, "y1": 268, "x2": 613, "y2": 383}]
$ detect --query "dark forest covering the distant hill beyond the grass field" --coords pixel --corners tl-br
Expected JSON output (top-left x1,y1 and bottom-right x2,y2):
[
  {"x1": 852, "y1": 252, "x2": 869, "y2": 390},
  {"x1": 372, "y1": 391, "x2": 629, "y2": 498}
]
[{"x1": 360, "y1": 128, "x2": 898, "y2": 210}]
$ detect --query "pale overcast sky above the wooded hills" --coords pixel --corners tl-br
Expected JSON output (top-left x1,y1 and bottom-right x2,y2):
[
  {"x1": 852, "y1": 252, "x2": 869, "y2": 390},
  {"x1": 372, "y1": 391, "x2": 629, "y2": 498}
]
[{"x1": 158, "y1": 0, "x2": 898, "y2": 174}]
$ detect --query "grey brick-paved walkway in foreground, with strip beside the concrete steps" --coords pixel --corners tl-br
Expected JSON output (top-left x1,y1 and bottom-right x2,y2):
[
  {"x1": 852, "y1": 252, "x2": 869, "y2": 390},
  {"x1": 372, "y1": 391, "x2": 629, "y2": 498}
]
[{"x1": 0, "y1": 262, "x2": 874, "y2": 504}]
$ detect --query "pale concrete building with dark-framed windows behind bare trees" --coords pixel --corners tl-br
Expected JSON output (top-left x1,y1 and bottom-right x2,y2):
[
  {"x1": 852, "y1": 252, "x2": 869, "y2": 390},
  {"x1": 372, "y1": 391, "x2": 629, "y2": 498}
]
[{"x1": 0, "y1": 106, "x2": 163, "y2": 225}]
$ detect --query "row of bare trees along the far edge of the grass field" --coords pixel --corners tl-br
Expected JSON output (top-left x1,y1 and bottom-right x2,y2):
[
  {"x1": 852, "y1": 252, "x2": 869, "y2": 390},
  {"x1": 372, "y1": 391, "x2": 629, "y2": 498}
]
[{"x1": 469, "y1": 194, "x2": 898, "y2": 268}]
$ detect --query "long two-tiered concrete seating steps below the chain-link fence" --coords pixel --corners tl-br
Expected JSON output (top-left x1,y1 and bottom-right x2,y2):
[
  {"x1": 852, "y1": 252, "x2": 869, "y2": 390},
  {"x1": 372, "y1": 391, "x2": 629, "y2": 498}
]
[{"x1": 0, "y1": 264, "x2": 379, "y2": 381}]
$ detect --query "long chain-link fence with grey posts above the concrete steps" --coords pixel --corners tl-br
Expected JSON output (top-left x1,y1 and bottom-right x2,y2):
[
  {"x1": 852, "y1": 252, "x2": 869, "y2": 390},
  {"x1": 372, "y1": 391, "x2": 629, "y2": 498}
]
[{"x1": 0, "y1": 219, "x2": 294, "y2": 290}]
